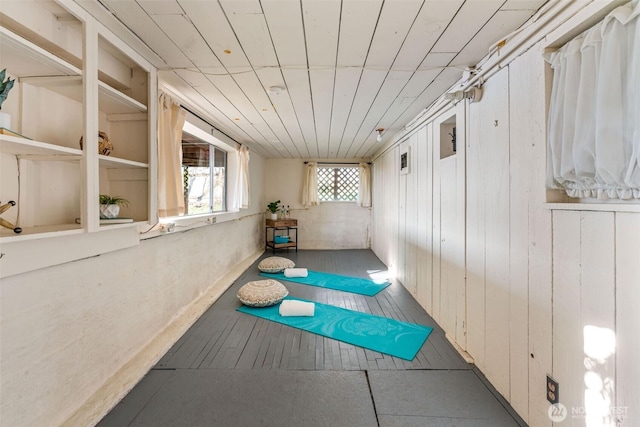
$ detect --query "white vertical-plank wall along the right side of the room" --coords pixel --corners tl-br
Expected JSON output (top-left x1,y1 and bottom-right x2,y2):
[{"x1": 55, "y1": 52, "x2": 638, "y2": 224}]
[{"x1": 372, "y1": 4, "x2": 640, "y2": 426}]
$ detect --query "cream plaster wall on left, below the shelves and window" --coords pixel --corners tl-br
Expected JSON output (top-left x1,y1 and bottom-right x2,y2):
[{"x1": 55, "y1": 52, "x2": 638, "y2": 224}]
[{"x1": 0, "y1": 153, "x2": 264, "y2": 426}]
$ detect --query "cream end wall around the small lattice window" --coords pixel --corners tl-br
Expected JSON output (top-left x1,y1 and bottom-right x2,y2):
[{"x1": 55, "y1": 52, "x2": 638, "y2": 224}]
[{"x1": 263, "y1": 159, "x2": 370, "y2": 249}]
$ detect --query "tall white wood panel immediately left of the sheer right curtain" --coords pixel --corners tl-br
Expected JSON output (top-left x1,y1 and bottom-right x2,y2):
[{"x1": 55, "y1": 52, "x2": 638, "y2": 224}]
[{"x1": 509, "y1": 39, "x2": 552, "y2": 426}]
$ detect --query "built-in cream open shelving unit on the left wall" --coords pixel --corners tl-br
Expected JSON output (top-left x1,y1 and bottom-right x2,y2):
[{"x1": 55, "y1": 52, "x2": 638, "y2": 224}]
[{"x1": 0, "y1": 0, "x2": 157, "y2": 254}]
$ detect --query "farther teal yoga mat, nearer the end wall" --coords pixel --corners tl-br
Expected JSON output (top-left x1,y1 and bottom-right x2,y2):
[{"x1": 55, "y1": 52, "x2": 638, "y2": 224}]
[{"x1": 260, "y1": 270, "x2": 391, "y2": 297}]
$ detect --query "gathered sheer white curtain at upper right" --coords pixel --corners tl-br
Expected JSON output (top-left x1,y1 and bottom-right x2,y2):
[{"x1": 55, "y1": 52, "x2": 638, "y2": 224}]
[{"x1": 547, "y1": 0, "x2": 640, "y2": 199}]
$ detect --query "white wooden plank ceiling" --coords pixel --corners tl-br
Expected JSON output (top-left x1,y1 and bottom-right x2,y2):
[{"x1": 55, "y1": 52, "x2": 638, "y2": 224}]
[{"x1": 99, "y1": 0, "x2": 545, "y2": 159}]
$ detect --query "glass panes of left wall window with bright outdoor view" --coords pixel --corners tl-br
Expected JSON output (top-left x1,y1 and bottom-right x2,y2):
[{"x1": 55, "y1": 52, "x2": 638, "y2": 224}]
[{"x1": 182, "y1": 133, "x2": 227, "y2": 215}]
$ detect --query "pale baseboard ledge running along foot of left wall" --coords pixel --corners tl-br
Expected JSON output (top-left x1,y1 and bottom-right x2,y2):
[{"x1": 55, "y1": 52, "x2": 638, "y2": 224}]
[{"x1": 62, "y1": 249, "x2": 264, "y2": 427}]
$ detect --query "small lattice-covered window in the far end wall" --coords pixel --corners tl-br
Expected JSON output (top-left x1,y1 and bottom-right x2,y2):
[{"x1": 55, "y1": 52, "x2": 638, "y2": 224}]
[{"x1": 318, "y1": 167, "x2": 360, "y2": 202}]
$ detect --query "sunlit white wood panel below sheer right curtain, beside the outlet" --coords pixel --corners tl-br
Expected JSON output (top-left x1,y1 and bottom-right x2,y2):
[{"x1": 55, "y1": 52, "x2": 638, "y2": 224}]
[{"x1": 553, "y1": 211, "x2": 616, "y2": 426}]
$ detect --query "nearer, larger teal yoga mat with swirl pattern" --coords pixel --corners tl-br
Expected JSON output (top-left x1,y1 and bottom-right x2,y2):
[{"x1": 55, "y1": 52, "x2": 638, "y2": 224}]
[{"x1": 237, "y1": 297, "x2": 433, "y2": 360}]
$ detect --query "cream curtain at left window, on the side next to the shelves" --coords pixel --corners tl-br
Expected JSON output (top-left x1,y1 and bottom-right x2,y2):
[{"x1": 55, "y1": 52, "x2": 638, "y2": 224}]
[{"x1": 158, "y1": 93, "x2": 186, "y2": 217}]
